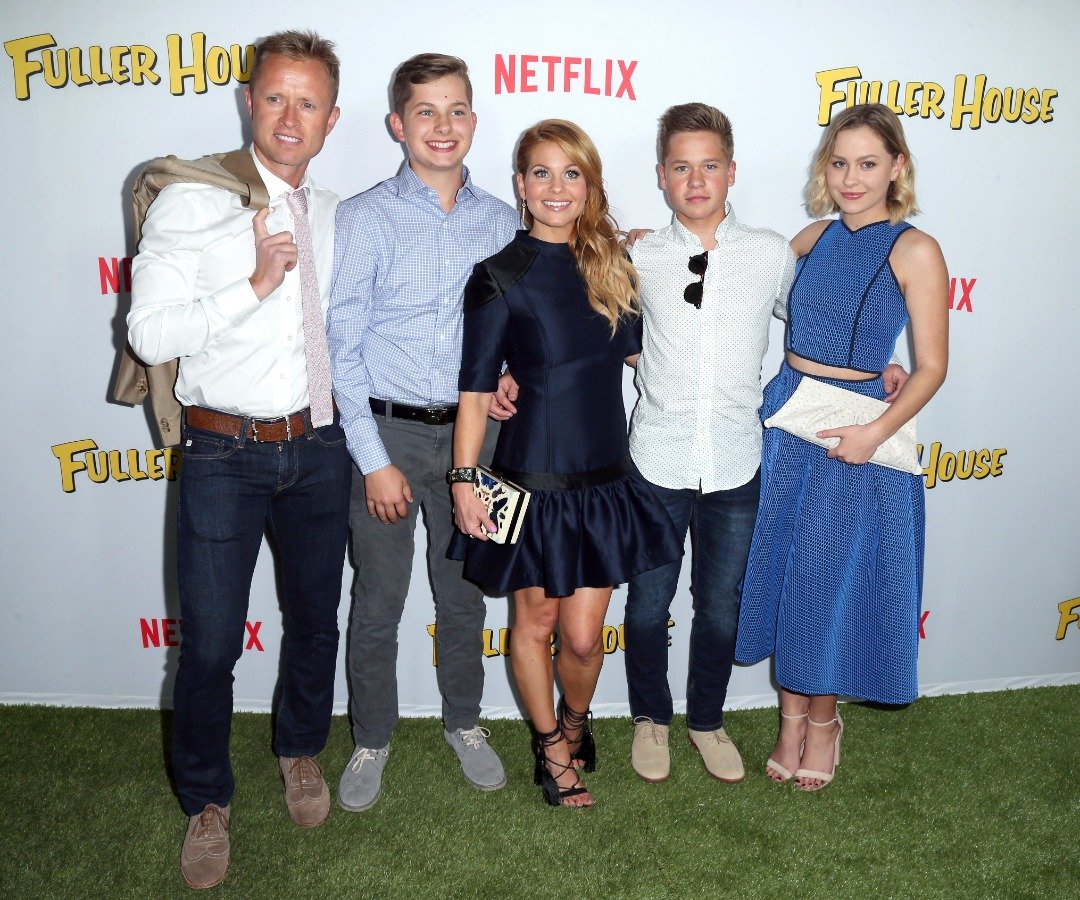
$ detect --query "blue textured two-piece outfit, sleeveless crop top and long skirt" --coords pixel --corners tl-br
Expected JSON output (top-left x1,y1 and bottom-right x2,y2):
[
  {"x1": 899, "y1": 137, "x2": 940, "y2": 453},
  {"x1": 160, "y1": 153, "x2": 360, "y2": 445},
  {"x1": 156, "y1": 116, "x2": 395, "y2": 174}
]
[{"x1": 735, "y1": 220, "x2": 924, "y2": 703}]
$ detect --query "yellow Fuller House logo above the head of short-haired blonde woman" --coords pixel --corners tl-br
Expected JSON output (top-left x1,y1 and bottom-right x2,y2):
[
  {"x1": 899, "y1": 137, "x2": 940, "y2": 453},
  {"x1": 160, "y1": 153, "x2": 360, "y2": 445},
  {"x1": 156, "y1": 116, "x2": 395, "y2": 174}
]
[{"x1": 818, "y1": 66, "x2": 1057, "y2": 131}]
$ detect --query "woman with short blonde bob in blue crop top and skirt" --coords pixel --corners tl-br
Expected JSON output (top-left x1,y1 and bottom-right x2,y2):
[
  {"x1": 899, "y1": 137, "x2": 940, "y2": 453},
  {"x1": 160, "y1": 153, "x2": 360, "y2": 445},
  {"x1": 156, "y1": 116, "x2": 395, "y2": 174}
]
[{"x1": 735, "y1": 104, "x2": 948, "y2": 791}]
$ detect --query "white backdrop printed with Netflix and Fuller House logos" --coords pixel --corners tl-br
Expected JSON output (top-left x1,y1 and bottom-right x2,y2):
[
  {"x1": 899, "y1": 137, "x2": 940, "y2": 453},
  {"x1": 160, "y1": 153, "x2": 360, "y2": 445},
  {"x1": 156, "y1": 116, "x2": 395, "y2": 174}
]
[{"x1": 0, "y1": 0, "x2": 1080, "y2": 715}]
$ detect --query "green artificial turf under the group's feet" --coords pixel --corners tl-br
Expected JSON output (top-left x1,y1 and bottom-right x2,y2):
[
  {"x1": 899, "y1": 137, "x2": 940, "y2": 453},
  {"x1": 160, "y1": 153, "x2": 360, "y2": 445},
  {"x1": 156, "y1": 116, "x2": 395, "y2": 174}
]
[{"x1": 0, "y1": 686, "x2": 1080, "y2": 899}]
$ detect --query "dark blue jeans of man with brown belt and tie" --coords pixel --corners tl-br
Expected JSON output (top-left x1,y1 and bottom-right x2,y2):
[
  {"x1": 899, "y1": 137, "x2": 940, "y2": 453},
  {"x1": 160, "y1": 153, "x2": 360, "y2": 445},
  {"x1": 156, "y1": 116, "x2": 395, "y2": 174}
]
[{"x1": 173, "y1": 414, "x2": 352, "y2": 816}]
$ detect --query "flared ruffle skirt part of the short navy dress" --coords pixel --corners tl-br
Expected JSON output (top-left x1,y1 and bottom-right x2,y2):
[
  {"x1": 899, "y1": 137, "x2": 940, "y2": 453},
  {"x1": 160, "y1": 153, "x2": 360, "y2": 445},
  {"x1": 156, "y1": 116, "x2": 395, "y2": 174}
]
[{"x1": 447, "y1": 460, "x2": 683, "y2": 596}]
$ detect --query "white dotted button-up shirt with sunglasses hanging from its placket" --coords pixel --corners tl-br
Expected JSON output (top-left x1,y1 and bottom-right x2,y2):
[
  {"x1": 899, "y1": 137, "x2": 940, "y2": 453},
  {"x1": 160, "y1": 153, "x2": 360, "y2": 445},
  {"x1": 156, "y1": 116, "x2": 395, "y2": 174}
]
[{"x1": 630, "y1": 203, "x2": 795, "y2": 493}]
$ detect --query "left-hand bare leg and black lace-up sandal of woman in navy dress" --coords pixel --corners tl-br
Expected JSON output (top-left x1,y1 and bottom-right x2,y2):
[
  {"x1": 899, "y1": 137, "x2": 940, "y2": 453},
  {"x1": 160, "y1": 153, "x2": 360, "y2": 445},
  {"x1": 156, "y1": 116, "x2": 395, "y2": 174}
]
[{"x1": 510, "y1": 588, "x2": 595, "y2": 806}]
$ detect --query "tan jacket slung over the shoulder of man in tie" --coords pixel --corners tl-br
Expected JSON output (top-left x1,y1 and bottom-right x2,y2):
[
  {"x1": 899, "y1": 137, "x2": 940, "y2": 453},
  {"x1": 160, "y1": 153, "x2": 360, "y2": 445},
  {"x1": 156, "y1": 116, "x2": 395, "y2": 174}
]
[{"x1": 112, "y1": 149, "x2": 270, "y2": 446}]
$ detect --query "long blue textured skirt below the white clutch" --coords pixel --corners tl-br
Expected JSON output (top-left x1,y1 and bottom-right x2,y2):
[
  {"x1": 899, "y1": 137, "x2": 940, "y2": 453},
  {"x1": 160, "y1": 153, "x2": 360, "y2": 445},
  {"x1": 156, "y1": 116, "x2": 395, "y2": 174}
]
[{"x1": 735, "y1": 363, "x2": 924, "y2": 703}]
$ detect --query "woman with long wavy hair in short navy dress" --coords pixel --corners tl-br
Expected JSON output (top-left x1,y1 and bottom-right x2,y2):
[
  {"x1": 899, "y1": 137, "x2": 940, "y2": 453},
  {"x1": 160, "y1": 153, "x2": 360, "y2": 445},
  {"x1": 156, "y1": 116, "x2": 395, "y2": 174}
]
[{"x1": 450, "y1": 119, "x2": 683, "y2": 806}]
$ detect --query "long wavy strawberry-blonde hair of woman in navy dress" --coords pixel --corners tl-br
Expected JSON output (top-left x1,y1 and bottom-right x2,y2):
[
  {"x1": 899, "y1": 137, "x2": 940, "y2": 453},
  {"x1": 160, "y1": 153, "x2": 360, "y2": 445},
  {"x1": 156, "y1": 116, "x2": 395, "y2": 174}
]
[{"x1": 514, "y1": 119, "x2": 638, "y2": 334}]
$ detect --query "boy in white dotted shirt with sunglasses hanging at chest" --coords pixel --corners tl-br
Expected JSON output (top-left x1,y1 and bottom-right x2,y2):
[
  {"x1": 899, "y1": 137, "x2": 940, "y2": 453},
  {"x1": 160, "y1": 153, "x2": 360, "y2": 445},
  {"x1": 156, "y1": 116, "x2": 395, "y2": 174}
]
[{"x1": 625, "y1": 103, "x2": 795, "y2": 782}]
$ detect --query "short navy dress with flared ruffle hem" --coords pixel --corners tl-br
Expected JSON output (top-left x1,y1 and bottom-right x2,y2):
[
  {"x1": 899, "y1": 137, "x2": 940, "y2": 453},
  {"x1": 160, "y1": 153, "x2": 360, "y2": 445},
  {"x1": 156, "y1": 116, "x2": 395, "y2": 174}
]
[{"x1": 450, "y1": 231, "x2": 683, "y2": 596}]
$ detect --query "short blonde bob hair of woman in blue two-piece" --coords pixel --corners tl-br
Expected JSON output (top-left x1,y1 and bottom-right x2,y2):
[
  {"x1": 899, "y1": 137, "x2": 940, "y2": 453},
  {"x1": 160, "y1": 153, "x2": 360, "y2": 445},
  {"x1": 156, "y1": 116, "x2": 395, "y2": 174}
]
[{"x1": 806, "y1": 103, "x2": 919, "y2": 225}]
